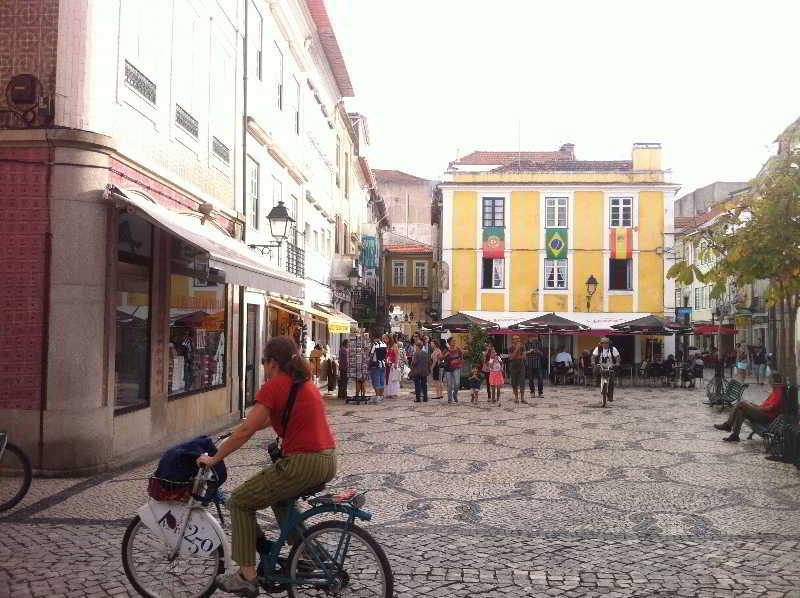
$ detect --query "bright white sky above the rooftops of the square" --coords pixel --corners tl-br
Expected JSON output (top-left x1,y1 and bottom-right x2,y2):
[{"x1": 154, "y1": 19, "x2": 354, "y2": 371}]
[{"x1": 327, "y1": 0, "x2": 800, "y2": 194}]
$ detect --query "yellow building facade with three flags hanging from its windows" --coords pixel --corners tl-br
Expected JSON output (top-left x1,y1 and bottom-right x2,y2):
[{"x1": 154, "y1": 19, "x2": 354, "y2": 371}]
[{"x1": 442, "y1": 143, "x2": 679, "y2": 359}]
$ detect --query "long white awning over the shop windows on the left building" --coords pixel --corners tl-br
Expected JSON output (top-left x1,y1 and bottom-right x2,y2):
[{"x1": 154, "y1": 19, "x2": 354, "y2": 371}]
[{"x1": 105, "y1": 185, "x2": 304, "y2": 297}]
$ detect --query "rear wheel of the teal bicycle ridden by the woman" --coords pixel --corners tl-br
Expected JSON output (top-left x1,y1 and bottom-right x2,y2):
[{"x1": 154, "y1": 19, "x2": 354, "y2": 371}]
[{"x1": 288, "y1": 521, "x2": 394, "y2": 598}]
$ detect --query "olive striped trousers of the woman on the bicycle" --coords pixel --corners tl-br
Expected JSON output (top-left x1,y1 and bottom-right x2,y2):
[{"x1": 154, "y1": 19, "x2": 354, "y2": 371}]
[{"x1": 228, "y1": 449, "x2": 336, "y2": 567}]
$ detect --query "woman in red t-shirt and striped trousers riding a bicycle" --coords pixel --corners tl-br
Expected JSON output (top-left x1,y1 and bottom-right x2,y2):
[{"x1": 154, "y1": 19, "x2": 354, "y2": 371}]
[{"x1": 202, "y1": 336, "x2": 336, "y2": 596}]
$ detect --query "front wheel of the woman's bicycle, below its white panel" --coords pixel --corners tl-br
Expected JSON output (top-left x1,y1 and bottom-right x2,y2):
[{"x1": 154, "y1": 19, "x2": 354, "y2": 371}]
[{"x1": 122, "y1": 515, "x2": 225, "y2": 598}]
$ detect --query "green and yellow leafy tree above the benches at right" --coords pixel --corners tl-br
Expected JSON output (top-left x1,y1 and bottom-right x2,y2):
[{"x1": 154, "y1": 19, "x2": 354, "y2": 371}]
[{"x1": 667, "y1": 125, "x2": 800, "y2": 382}]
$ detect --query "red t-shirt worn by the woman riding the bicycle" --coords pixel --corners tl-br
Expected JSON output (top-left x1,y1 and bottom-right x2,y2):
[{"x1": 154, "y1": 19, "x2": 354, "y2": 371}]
[{"x1": 256, "y1": 374, "x2": 336, "y2": 455}]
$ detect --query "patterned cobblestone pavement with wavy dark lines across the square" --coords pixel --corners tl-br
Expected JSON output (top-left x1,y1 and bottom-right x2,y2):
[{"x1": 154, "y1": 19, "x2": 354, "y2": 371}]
[{"x1": 0, "y1": 386, "x2": 800, "y2": 598}]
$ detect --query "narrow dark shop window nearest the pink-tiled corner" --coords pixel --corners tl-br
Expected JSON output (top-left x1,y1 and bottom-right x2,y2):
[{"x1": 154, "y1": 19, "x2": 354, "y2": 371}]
[{"x1": 114, "y1": 212, "x2": 153, "y2": 413}]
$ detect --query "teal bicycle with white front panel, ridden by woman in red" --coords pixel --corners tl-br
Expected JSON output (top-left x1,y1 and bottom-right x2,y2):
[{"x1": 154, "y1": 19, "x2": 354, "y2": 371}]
[{"x1": 122, "y1": 434, "x2": 394, "y2": 598}]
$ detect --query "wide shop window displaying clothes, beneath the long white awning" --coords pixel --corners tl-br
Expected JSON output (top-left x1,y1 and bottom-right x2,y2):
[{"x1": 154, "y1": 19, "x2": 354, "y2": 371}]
[{"x1": 168, "y1": 239, "x2": 227, "y2": 397}]
